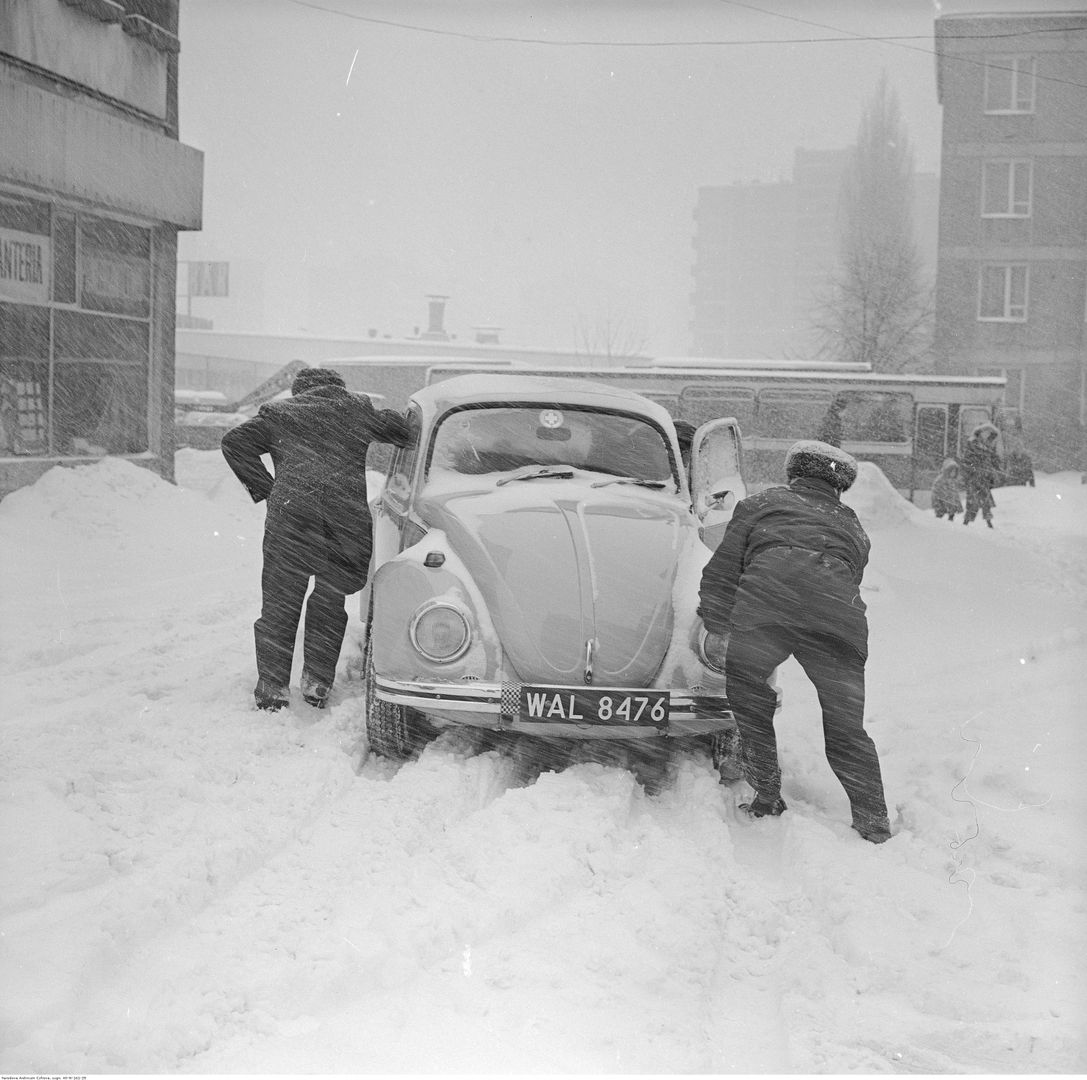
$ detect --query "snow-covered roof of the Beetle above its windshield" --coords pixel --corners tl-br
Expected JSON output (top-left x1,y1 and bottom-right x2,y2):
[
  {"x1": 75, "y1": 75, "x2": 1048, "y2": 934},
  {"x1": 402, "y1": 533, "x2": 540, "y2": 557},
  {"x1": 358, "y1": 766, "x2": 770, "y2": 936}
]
[{"x1": 411, "y1": 373, "x2": 672, "y2": 430}]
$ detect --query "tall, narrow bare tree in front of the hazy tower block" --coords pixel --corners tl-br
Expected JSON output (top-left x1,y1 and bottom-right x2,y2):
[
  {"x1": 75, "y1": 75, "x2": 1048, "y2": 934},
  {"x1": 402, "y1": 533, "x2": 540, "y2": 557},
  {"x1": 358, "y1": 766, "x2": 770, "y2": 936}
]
[{"x1": 815, "y1": 74, "x2": 933, "y2": 372}]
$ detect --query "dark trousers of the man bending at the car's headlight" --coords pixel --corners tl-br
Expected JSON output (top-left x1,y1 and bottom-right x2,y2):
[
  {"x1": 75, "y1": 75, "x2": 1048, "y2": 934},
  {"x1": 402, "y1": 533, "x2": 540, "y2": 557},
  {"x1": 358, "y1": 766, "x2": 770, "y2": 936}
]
[{"x1": 725, "y1": 626, "x2": 887, "y2": 825}]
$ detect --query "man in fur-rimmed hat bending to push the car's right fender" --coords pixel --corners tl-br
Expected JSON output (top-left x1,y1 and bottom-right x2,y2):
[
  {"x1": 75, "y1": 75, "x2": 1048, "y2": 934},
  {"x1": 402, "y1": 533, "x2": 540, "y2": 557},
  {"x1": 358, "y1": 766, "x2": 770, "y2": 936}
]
[{"x1": 699, "y1": 440, "x2": 890, "y2": 843}]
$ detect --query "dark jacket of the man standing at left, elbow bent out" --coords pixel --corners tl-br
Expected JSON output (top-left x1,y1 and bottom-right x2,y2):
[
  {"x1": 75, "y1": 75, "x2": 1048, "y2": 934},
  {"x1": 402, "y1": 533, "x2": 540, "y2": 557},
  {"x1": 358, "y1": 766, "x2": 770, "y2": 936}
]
[{"x1": 223, "y1": 385, "x2": 409, "y2": 593}]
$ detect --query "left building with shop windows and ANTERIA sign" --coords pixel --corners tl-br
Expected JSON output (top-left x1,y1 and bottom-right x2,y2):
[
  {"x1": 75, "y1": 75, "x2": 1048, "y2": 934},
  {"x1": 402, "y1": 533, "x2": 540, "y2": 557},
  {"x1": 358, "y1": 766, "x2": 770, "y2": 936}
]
[{"x1": 0, "y1": 0, "x2": 203, "y2": 494}]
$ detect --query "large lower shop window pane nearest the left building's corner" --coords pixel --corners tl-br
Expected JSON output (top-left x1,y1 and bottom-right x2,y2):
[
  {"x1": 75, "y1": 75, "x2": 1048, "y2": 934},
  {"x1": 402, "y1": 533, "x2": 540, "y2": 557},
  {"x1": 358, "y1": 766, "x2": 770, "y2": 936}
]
[{"x1": 53, "y1": 311, "x2": 149, "y2": 456}]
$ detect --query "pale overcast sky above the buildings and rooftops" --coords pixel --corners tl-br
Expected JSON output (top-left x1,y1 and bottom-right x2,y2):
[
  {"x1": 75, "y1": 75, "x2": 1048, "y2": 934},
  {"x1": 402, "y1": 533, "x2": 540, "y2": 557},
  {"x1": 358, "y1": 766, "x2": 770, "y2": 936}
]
[{"x1": 180, "y1": 0, "x2": 1077, "y2": 354}]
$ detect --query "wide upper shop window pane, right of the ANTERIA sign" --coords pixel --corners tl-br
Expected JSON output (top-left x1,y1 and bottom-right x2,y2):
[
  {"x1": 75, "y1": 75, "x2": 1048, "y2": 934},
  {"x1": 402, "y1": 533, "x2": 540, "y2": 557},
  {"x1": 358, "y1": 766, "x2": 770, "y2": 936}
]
[{"x1": 79, "y1": 215, "x2": 151, "y2": 318}]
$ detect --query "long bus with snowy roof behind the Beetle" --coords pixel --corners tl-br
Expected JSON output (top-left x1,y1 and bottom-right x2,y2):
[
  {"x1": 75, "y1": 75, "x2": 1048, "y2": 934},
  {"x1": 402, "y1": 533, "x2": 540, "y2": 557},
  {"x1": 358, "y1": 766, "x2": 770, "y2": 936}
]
[{"x1": 419, "y1": 363, "x2": 1007, "y2": 504}]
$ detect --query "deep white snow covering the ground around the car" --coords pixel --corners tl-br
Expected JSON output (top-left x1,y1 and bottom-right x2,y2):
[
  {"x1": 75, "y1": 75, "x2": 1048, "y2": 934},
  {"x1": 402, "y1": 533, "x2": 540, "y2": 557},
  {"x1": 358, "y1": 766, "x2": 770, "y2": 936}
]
[{"x1": 0, "y1": 451, "x2": 1087, "y2": 1073}]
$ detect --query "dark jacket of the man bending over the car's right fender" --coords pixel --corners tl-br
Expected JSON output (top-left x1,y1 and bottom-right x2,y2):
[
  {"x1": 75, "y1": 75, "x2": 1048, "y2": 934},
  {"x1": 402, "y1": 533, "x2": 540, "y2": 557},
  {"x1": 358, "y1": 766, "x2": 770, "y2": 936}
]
[{"x1": 699, "y1": 477, "x2": 871, "y2": 656}]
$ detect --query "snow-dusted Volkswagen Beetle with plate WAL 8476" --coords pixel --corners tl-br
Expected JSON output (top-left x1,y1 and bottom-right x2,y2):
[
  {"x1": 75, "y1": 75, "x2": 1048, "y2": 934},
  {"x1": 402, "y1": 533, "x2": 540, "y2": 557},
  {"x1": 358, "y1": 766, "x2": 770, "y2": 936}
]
[{"x1": 362, "y1": 374, "x2": 746, "y2": 761}]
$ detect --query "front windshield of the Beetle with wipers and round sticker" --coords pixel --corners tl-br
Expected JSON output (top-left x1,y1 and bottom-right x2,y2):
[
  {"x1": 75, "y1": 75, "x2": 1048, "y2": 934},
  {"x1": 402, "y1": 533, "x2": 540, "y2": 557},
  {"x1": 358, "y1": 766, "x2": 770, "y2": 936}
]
[{"x1": 427, "y1": 404, "x2": 675, "y2": 484}]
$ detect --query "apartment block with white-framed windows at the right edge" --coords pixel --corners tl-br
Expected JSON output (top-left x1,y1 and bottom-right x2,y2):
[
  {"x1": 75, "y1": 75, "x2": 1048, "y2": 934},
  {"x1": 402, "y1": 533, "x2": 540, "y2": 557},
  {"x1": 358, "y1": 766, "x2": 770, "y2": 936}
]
[{"x1": 935, "y1": 11, "x2": 1087, "y2": 468}]
